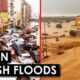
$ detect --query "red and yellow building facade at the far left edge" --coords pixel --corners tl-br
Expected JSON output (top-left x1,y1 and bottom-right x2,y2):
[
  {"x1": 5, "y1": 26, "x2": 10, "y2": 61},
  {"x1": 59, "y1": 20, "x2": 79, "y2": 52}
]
[{"x1": 0, "y1": 0, "x2": 8, "y2": 34}]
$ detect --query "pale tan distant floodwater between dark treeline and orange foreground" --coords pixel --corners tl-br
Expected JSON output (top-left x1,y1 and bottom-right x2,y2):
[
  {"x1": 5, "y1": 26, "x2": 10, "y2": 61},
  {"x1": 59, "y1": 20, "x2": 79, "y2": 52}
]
[{"x1": 42, "y1": 21, "x2": 75, "y2": 36}]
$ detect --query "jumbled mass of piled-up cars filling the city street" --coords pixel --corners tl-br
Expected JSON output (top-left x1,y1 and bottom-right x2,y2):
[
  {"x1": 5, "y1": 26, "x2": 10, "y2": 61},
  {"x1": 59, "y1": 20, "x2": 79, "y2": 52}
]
[{"x1": 0, "y1": 25, "x2": 39, "y2": 64}]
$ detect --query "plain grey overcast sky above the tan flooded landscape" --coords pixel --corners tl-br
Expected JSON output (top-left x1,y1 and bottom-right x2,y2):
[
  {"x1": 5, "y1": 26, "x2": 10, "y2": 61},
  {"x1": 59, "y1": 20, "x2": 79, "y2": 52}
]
[{"x1": 42, "y1": 0, "x2": 80, "y2": 16}]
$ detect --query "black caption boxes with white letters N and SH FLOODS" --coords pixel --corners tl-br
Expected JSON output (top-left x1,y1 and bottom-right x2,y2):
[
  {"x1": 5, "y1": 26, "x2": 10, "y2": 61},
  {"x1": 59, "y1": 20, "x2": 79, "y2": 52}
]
[{"x1": 0, "y1": 51, "x2": 60, "y2": 76}]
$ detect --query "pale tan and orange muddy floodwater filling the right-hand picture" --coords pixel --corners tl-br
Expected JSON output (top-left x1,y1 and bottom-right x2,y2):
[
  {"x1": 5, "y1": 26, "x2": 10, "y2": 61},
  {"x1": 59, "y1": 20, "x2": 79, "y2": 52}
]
[{"x1": 42, "y1": 21, "x2": 80, "y2": 80}]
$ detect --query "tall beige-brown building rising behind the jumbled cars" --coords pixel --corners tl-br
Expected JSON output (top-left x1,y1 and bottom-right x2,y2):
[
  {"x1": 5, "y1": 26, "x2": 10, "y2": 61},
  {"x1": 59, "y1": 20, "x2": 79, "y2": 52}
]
[{"x1": 21, "y1": 0, "x2": 31, "y2": 28}]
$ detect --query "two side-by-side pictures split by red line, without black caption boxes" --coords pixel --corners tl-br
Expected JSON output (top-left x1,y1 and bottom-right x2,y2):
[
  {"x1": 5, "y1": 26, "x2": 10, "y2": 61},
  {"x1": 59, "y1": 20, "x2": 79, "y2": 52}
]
[{"x1": 0, "y1": 0, "x2": 80, "y2": 80}]
